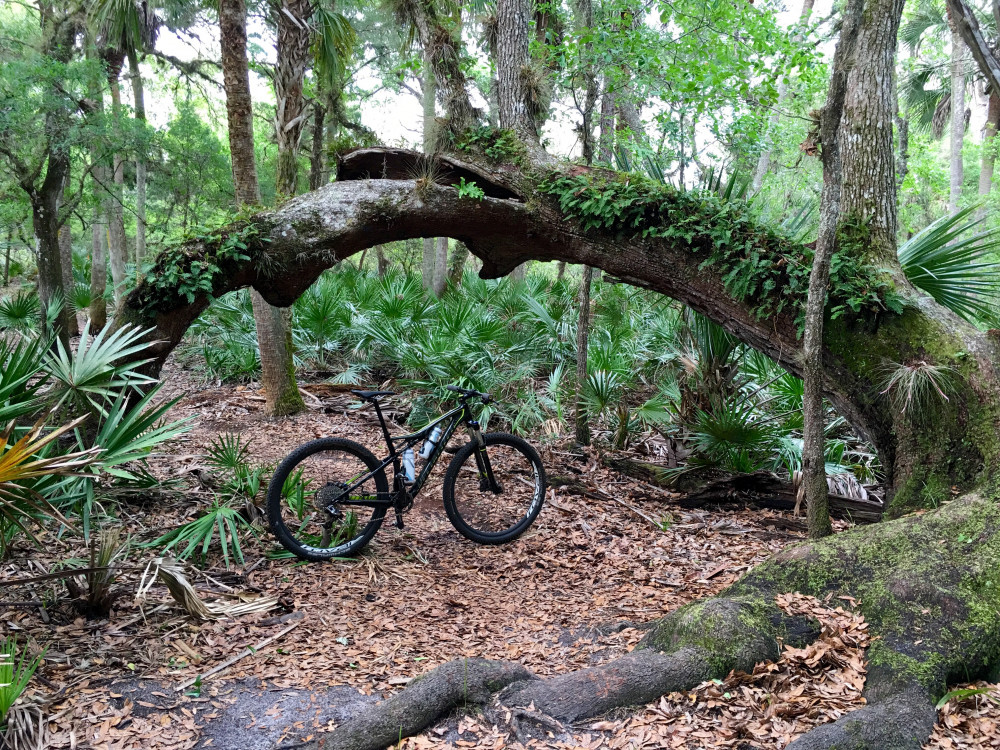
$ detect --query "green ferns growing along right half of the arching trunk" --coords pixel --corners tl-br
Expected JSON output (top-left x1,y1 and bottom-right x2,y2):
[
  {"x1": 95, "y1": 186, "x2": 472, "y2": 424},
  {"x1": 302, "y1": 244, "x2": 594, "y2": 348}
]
[{"x1": 538, "y1": 172, "x2": 902, "y2": 329}]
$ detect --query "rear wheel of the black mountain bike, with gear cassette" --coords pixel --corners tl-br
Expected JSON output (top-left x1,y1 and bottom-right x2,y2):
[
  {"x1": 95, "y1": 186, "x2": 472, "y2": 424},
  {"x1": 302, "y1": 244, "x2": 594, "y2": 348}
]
[{"x1": 267, "y1": 438, "x2": 389, "y2": 561}]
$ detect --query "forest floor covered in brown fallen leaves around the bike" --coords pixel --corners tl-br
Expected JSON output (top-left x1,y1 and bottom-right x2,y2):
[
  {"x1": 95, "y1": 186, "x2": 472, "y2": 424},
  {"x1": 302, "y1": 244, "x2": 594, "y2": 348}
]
[{"x1": 0, "y1": 368, "x2": 1000, "y2": 750}]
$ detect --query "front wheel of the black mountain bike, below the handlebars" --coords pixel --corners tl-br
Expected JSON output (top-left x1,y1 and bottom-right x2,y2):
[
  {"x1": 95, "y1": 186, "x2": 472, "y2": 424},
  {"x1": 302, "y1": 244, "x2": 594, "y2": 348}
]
[{"x1": 444, "y1": 432, "x2": 545, "y2": 544}]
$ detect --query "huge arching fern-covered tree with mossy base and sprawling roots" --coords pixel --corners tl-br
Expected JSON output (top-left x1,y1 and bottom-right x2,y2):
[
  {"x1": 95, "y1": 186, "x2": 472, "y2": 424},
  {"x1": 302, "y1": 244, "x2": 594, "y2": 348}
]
[{"x1": 116, "y1": 0, "x2": 1000, "y2": 750}]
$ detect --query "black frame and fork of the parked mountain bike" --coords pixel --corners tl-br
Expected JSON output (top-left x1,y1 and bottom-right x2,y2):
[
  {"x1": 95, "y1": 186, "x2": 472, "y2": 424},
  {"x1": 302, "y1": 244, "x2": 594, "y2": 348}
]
[{"x1": 330, "y1": 401, "x2": 501, "y2": 509}]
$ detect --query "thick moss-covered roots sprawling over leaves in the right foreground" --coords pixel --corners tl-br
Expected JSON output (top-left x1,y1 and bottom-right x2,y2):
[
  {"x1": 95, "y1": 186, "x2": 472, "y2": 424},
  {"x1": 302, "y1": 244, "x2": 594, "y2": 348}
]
[{"x1": 272, "y1": 494, "x2": 1000, "y2": 750}]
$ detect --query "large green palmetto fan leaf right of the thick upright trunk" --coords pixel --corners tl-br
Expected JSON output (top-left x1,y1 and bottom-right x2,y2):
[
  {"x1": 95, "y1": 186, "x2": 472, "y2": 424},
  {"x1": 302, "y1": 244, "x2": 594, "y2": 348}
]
[{"x1": 899, "y1": 206, "x2": 1000, "y2": 325}]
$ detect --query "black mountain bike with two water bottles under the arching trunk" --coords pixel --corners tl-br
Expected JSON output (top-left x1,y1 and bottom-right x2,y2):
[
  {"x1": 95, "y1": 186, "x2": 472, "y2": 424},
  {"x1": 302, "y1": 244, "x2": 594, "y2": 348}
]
[{"x1": 267, "y1": 386, "x2": 545, "y2": 561}]
